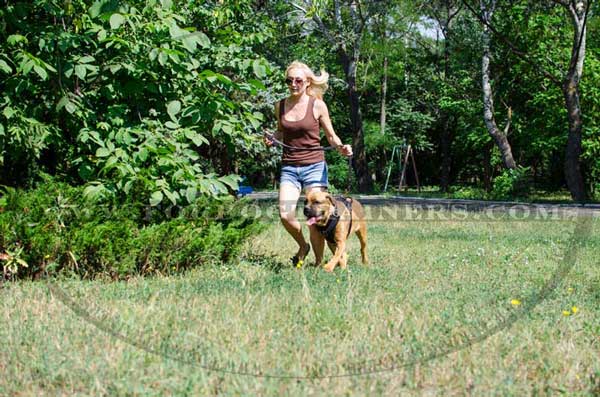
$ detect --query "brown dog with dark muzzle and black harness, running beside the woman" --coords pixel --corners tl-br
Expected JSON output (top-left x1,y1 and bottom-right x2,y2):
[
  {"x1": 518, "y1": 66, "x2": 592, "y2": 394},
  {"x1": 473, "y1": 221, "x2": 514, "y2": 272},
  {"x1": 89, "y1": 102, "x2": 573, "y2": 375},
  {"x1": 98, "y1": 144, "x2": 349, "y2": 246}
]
[{"x1": 304, "y1": 191, "x2": 369, "y2": 272}]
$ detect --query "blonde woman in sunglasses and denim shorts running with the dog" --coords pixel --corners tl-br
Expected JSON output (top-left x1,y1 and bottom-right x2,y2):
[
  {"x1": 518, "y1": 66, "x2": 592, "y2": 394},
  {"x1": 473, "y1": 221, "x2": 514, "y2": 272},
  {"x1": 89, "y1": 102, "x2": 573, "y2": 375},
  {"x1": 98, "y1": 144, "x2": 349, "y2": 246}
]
[{"x1": 265, "y1": 61, "x2": 352, "y2": 266}]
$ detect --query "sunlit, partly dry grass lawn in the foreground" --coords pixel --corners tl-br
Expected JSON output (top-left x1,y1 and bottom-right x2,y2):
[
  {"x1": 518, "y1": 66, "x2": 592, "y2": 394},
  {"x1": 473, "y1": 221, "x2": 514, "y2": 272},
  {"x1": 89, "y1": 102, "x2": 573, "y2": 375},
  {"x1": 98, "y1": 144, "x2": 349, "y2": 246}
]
[{"x1": 0, "y1": 208, "x2": 600, "y2": 396}]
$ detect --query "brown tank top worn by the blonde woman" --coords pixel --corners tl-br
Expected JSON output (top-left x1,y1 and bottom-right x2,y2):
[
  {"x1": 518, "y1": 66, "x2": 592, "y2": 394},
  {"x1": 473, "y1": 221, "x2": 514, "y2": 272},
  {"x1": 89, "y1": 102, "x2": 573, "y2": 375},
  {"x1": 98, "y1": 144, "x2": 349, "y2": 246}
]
[{"x1": 279, "y1": 97, "x2": 325, "y2": 165}]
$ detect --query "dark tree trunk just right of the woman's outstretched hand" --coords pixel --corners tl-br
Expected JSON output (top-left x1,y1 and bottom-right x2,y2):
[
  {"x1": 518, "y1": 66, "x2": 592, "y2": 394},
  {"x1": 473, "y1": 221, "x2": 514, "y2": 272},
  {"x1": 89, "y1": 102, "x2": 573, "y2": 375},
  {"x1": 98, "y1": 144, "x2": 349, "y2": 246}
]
[{"x1": 338, "y1": 48, "x2": 373, "y2": 193}]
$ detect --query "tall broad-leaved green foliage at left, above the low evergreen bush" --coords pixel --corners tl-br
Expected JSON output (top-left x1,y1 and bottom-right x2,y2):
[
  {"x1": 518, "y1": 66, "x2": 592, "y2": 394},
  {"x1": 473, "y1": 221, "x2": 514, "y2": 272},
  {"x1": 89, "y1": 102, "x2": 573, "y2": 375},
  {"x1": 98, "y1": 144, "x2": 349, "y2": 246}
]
[{"x1": 0, "y1": 0, "x2": 272, "y2": 205}]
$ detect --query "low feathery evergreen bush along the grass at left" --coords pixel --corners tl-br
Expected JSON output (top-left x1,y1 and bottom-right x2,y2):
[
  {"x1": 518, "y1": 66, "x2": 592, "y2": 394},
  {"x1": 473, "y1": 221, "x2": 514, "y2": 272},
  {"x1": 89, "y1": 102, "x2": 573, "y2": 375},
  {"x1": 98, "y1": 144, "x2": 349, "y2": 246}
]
[{"x1": 0, "y1": 181, "x2": 261, "y2": 278}]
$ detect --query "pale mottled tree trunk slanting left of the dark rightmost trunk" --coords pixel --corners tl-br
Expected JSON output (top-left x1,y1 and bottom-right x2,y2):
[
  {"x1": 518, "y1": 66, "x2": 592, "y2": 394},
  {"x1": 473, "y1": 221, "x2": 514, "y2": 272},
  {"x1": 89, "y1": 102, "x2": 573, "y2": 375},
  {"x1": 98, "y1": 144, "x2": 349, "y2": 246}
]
[{"x1": 481, "y1": 2, "x2": 517, "y2": 169}]
